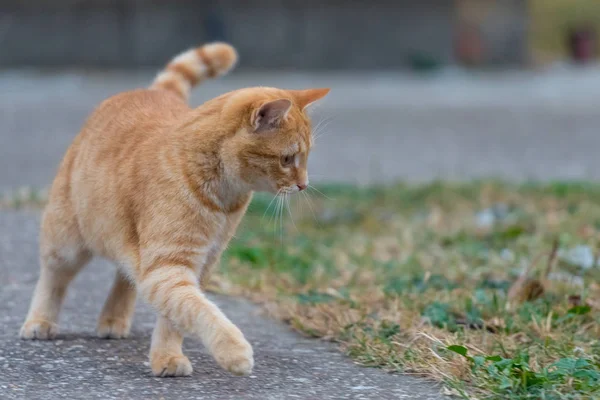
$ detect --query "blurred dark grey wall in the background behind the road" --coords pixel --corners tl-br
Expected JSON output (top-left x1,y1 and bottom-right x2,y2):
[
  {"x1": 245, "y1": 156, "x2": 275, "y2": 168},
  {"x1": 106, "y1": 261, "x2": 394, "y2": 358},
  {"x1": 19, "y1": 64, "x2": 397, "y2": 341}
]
[{"x1": 0, "y1": 0, "x2": 530, "y2": 70}]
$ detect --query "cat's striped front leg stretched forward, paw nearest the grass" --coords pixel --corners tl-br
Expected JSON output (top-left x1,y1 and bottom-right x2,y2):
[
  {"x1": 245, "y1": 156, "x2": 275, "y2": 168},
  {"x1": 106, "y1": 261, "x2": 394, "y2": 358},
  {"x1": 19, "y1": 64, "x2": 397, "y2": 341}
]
[{"x1": 139, "y1": 255, "x2": 254, "y2": 375}]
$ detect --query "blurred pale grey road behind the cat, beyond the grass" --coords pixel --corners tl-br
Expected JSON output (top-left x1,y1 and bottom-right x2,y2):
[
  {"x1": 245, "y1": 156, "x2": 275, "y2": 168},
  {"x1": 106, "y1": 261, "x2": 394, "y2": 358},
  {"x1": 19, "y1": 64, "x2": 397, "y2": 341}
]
[{"x1": 0, "y1": 68, "x2": 600, "y2": 190}]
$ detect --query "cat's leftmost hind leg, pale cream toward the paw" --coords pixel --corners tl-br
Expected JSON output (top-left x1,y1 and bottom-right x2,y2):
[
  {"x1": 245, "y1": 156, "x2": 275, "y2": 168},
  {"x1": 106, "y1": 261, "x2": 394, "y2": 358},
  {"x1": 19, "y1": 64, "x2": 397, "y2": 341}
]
[{"x1": 20, "y1": 204, "x2": 91, "y2": 339}]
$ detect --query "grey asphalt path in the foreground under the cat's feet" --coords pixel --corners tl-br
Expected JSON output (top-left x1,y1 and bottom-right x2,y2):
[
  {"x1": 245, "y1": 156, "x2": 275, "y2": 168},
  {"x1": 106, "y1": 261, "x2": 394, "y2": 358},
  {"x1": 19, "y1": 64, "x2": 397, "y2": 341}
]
[{"x1": 0, "y1": 211, "x2": 442, "y2": 400}]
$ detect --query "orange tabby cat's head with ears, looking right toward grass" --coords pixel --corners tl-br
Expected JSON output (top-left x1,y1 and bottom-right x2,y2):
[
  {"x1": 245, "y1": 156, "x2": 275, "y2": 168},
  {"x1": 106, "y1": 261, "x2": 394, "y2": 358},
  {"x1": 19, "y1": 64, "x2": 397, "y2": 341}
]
[{"x1": 223, "y1": 88, "x2": 329, "y2": 193}]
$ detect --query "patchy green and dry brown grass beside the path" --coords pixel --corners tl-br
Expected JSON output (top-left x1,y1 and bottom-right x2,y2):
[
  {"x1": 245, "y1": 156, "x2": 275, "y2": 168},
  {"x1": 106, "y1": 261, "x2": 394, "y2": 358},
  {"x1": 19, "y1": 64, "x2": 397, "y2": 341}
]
[{"x1": 216, "y1": 182, "x2": 600, "y2": 399}]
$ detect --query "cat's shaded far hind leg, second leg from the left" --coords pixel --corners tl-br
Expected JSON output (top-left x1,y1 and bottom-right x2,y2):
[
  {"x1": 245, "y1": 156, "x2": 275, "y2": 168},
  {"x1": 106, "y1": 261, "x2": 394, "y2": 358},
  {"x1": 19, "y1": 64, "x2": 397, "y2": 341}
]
[{"x1": 96, "y1": 270, "x2": 137, "y2": 339}]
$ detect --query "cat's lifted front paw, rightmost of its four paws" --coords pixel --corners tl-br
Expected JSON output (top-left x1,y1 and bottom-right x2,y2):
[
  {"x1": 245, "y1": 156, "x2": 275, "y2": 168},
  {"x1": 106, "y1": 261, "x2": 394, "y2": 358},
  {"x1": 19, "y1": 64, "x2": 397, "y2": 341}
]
[{"x1": 213, "y1": 336, "x2": 254, "y2": 375}]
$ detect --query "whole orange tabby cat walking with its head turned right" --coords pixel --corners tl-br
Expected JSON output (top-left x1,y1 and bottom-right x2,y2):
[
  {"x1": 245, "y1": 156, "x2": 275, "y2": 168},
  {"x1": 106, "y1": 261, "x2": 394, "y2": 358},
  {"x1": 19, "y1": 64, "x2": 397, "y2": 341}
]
[{"x1": 21, "y1": 43, "x2": 329, "y2": 376}]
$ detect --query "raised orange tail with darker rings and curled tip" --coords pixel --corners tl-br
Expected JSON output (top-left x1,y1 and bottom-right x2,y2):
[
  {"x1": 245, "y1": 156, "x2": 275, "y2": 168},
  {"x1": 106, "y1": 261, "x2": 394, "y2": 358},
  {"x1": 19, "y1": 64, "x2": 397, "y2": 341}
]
[{"x1": 150, "y1": 42, "x2": 238, "y2": 100}]
